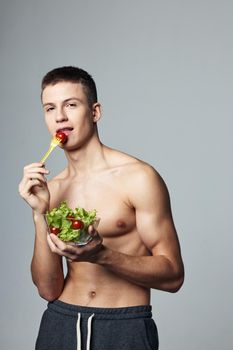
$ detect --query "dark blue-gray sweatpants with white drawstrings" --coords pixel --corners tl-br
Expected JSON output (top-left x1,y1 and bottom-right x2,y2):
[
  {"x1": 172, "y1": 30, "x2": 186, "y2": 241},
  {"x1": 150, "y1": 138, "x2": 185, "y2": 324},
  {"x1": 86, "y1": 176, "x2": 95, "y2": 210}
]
[{"x1": 35, "y1": 300, "x2": 158, "y2": 350}]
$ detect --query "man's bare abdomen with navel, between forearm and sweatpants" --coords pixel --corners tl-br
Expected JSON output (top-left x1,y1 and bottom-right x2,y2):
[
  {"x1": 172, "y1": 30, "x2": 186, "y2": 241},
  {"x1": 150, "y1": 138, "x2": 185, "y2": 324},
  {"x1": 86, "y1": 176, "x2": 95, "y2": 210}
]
[{"x1": 59, "y1": 263, "x2": 150, "y2": 307}]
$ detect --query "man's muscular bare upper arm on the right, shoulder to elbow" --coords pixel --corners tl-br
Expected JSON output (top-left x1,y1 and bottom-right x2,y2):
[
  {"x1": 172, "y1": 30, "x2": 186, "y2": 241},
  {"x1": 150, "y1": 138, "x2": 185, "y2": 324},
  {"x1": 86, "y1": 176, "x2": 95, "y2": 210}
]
[{"x1": 130, "y1": 169, "x2": 181, "y2": 263}]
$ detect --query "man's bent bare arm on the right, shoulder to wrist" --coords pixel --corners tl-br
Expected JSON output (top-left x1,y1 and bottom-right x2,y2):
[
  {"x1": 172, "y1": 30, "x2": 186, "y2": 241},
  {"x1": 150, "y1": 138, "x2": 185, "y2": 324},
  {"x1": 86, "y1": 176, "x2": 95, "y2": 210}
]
[{"x1": 93, "y1": 165, "x2": 184, "y2": 292}]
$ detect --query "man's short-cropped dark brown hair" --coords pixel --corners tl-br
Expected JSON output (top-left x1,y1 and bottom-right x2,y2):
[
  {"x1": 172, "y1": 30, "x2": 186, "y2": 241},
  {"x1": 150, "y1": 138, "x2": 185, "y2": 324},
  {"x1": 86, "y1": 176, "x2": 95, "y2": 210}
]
[{"x1": 41, "y1": 66, "x2": 97, "y2": 107}]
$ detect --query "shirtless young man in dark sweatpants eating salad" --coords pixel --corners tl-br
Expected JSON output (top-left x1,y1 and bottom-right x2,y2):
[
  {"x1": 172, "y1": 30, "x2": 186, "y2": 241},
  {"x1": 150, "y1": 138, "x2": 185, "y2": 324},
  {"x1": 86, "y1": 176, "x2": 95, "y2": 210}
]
[{"x1": 19, "y1": 67, "x2": 184, "y2": 350}]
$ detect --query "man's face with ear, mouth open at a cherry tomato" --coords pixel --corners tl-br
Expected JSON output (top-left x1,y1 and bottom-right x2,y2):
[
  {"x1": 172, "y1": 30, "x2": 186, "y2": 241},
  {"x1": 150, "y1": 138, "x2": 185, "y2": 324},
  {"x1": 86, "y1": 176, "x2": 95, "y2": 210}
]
[{"x1": 42, "y1": 82, "x2": 98, "y2": 149}]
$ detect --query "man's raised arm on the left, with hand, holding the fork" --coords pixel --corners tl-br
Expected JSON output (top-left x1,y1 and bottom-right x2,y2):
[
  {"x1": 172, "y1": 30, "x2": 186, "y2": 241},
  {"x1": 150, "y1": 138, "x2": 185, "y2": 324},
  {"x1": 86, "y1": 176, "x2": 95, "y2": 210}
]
[{"x1": 19, "y1": 163, "x2": 64, "y2": 300}]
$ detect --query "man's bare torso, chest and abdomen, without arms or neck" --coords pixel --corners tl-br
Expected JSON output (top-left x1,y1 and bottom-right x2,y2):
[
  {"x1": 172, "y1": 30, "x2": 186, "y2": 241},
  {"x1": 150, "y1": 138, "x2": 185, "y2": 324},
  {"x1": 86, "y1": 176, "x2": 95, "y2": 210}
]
[{"x1": 50, "y1": 150, "x2": 150, "y2": 307}]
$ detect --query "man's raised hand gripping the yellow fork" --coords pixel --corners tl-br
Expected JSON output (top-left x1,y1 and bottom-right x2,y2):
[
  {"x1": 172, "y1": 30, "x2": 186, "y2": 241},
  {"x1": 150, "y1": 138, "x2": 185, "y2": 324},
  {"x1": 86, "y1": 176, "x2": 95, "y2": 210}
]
[{"x1": 19, "y1": 163, "x2": 50, "y2": 214}]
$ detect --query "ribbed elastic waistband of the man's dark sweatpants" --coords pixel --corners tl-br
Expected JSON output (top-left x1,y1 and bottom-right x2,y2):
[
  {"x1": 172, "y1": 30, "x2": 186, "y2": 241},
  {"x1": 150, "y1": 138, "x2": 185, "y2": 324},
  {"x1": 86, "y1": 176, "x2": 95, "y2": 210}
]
[{"x1": 48, "y1": 300, "x2": 152, "y2": 320}]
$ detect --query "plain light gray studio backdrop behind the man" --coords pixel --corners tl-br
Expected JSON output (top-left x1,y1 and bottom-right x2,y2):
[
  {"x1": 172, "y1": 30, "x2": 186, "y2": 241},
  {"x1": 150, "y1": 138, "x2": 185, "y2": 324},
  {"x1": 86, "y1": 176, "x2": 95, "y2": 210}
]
[{"x1": 0, "y1": 0, "x2": 233, "y2": 350}]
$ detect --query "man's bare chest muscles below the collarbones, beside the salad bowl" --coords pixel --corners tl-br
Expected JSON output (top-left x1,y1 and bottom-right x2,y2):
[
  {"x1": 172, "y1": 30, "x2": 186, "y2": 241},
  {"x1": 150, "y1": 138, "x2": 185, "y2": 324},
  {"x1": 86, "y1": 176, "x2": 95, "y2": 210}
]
[{"x1": 52, "y1": 178, "x2": 136, "y2": 237}]
